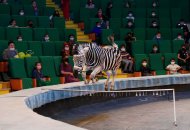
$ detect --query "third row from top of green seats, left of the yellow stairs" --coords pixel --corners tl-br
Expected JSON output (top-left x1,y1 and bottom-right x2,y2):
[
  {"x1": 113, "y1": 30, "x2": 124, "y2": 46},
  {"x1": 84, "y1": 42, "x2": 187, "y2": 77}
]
[{"x1": 0, "y1": 27, "x2": 77, "y2": 41}]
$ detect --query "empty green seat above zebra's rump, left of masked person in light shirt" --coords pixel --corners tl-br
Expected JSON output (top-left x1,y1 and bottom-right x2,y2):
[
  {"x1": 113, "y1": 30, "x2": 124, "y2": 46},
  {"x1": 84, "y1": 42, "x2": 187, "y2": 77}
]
[{"x1": 110, "y1": 18, "x2": 121, "y2": 40}]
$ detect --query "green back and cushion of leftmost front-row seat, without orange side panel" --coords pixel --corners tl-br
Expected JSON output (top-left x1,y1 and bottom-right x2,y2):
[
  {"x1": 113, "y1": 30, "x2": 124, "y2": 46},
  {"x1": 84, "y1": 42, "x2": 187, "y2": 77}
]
[{"x1": 8, "y1": 58, "x2": 32, "y2": 89}]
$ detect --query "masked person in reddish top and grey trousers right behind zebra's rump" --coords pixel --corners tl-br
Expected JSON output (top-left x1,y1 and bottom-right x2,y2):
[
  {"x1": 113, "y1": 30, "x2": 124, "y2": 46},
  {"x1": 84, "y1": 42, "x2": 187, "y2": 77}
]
[{"x1": 120, "y1": 45, "x2": 133, "y2": 73}]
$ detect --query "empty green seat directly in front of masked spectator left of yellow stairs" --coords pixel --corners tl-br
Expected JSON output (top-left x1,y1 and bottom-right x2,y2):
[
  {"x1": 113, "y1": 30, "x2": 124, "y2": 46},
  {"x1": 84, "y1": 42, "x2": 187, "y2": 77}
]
[{"x1": 42, "y1": 42, "x2": 55, "y2": 56}]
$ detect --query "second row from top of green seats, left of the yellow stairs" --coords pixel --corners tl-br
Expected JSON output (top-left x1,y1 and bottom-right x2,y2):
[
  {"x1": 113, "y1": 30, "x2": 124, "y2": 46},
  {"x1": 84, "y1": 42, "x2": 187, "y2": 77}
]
[{"x1": 0, "y1": 14, "x2": 65, "y2": 29}]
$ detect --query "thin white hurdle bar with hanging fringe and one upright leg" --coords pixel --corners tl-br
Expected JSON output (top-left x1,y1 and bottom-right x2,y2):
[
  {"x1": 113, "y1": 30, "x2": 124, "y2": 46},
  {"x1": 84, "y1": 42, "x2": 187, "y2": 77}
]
[{"x1": 42, "y1": 88, "x2": 177, "y2": 126}]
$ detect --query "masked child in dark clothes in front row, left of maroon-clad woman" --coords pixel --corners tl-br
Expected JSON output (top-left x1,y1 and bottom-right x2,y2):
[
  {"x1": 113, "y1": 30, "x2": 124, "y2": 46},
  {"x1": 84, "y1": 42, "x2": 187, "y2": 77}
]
[{"x1": 32, "y1": 62, "x2": 51, "y2": 87}]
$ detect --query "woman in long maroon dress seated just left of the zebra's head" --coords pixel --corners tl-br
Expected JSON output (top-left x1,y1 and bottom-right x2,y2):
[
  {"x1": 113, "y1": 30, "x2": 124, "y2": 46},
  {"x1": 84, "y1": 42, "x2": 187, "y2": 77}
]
[{"x1": 61, "y1": 57, "x2": 79, "y2": 83}]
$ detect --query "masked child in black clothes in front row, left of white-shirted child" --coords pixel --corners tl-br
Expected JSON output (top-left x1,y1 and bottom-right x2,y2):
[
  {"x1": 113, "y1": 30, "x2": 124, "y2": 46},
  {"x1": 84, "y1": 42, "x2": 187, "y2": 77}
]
[{"x1": 140, "y1": 59, "x2": 152, "y2": 76}]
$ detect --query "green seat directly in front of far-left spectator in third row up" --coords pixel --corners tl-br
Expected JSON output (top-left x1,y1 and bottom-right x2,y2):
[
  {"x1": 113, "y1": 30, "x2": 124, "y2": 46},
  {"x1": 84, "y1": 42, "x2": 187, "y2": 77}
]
[{"x1": 6, "y1": 28, "x2": 19, "y2": 40}]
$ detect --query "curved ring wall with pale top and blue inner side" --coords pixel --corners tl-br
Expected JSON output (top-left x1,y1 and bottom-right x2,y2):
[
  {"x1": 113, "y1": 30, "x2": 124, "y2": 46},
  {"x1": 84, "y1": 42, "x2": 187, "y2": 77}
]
[{"x1": 0, "y1": 74, "x2": 190, "y2": 130}]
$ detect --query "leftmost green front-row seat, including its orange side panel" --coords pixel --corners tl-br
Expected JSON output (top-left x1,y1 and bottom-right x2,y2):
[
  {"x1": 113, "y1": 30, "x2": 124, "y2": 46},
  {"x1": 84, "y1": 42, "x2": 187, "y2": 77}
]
[{"x1": 8, "y1": 58, "x2": 33, "y2": 90}]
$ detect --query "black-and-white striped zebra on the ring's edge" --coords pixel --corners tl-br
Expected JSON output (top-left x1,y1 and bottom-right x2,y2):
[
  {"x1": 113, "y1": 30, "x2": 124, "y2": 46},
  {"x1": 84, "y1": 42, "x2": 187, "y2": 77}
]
[{"x1": 73, "y1": 43, "x2": 122, "y2": 90}]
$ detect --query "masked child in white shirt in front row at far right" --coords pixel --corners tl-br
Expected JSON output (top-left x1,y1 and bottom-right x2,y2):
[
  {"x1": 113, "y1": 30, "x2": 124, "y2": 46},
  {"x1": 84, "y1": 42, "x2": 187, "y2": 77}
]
[{"x1": 166, "y1": 58, "x2": 181, "y2": 74}]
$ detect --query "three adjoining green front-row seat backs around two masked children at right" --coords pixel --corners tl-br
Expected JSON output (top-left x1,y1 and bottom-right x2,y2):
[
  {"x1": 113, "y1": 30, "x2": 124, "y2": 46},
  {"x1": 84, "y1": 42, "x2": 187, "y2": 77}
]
[{"x1": 134, "y1": 53, "x2": 178, "y2": 75}]
